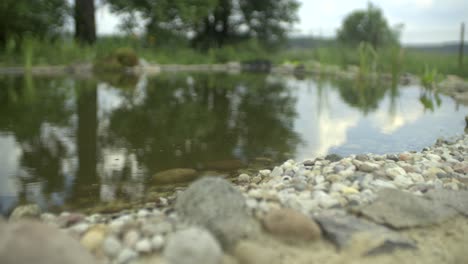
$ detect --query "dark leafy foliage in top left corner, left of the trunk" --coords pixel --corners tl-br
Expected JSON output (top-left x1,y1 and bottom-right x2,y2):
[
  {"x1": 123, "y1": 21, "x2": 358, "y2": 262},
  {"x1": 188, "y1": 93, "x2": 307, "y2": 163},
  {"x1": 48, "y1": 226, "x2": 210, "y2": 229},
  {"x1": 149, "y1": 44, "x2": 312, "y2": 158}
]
[{"x1": 0, "y1": 0, "x2": 70, "y2": 46}]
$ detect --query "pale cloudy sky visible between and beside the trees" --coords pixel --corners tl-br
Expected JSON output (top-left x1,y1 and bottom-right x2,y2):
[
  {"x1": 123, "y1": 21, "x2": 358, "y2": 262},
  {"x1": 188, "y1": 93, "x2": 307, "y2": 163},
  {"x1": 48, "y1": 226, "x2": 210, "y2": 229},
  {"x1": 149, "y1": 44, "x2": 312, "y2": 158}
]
[{"x1": 96, "y1": 0, "x2": 468, "y2": 44}]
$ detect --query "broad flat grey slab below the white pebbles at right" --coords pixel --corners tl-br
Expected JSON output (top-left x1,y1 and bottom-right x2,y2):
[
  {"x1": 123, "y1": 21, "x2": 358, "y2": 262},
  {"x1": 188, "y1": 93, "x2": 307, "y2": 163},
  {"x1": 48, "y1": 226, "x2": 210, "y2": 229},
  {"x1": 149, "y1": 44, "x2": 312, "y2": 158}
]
[{"x1": 358, "y1": 188, "x2": 457, "y2": 228}]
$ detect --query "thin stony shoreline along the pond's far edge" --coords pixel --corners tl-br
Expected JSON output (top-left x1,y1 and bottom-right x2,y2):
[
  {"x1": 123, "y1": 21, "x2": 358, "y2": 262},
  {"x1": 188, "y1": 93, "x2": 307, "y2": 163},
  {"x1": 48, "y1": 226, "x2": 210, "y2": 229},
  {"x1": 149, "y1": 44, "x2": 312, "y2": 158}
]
[{"x1": 0, "y1": 62, "x2": 468, "y2": 105}]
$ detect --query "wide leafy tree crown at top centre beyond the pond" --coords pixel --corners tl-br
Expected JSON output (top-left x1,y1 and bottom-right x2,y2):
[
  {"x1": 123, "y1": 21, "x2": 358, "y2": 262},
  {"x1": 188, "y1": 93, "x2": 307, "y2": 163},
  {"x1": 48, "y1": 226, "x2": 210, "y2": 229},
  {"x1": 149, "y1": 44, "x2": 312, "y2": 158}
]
[{"x1": 107, "y1": 0, "x2": 299, "y2": 49}]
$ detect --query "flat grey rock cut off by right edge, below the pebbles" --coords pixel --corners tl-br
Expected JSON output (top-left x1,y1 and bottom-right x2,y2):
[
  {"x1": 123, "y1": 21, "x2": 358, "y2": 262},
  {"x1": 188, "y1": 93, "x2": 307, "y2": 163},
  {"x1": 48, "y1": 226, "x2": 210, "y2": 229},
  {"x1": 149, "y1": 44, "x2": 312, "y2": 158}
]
[{"x1": 425, "y1": 189, "x2": 468, "y2": 216}]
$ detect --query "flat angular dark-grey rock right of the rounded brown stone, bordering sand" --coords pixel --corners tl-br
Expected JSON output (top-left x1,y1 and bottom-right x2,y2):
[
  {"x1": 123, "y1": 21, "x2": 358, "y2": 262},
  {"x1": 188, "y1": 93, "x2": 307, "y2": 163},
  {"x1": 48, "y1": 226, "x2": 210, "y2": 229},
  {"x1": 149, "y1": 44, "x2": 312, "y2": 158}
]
[{"x1": 315, "y1": 211, "x2": 416, "y2": 255}]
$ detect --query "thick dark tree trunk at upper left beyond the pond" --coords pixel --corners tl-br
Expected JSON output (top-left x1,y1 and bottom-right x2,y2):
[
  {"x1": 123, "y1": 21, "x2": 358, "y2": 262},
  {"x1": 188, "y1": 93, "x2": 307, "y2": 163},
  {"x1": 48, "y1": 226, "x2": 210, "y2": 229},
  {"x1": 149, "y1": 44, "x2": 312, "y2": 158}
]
[{"x1": 75, "y1": 0, "x2": 96, "y2": 44}]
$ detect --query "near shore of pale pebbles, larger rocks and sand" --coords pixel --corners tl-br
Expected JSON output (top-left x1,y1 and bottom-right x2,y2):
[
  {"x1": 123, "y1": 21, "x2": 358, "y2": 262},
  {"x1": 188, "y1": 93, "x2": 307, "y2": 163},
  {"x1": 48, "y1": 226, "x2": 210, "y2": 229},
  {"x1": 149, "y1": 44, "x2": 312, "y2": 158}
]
[{"x1": 0, "y1": 134, "x2": 468, "y2": 263}]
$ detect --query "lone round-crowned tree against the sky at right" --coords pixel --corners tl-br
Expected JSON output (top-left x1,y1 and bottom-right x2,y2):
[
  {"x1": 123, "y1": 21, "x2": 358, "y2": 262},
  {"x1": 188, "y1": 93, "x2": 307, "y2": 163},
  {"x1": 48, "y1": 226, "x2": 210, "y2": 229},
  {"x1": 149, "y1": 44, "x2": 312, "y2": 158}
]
[{"x1": 337, "y1": 3, "x2": 401, "y2": 48}]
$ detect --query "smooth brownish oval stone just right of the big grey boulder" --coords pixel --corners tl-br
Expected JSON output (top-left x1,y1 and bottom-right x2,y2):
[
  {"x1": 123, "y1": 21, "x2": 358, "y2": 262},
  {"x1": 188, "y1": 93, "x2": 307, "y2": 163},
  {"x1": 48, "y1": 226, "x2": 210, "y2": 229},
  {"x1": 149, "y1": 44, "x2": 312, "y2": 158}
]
[{"x1": 262, "y1": 208, "x2": 321, "y2": 241}]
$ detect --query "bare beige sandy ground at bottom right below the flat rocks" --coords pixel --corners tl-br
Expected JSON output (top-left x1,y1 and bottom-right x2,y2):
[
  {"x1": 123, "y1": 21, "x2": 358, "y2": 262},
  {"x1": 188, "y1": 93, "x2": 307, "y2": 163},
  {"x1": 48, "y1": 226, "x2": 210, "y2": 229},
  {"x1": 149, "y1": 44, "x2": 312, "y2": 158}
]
[{"x1": 224, "y1": 216, "x2": 468, "y2": 264}]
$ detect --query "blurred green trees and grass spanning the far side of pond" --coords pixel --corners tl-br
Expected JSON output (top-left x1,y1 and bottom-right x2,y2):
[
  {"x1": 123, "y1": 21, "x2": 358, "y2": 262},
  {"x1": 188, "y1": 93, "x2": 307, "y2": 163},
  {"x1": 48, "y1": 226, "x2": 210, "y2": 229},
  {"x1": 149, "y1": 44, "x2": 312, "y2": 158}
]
[{"x1": 0, "y1": 0, "x2": 468, "y2": 77}]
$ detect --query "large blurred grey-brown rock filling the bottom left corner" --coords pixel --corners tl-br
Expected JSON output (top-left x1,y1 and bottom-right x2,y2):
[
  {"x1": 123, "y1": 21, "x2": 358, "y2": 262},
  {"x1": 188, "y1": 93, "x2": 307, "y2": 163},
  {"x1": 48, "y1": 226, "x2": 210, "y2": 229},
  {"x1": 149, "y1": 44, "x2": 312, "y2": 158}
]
[{"x1": 0, "y1": 220, "x2": 96, "y2": 264}]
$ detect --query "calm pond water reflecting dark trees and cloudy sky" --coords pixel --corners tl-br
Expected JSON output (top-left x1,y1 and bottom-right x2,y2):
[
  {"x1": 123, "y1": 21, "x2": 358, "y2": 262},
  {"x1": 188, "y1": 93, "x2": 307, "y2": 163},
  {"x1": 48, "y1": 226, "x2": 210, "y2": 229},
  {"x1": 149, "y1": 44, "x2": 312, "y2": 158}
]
[{"x1": 0, "y1": 73, "x2": 468, "y2": 214}]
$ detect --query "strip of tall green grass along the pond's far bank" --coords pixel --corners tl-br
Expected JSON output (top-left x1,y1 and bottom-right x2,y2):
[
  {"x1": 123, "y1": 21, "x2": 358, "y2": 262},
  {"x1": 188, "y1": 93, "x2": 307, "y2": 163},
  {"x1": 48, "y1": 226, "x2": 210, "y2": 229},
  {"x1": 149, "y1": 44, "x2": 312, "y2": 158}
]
[{"x1": 0, "y1": 37, "x2": 468, "y2": 78}]
